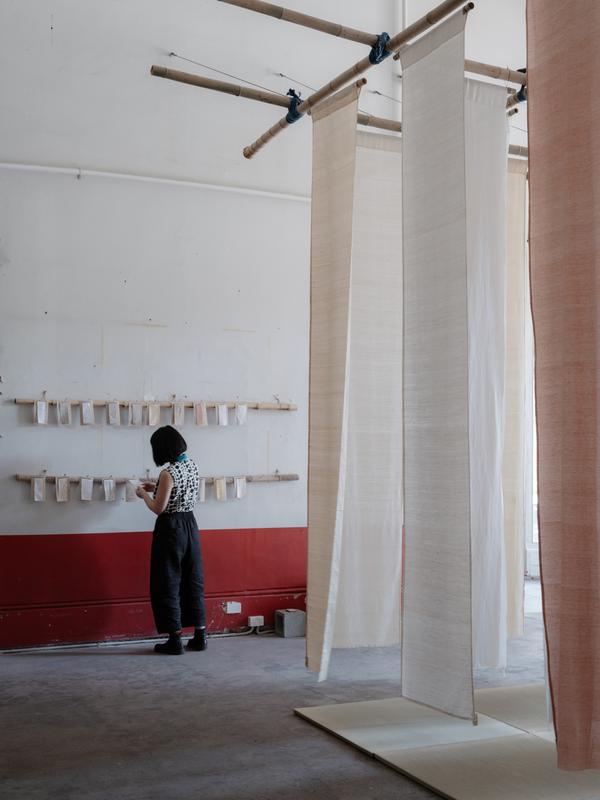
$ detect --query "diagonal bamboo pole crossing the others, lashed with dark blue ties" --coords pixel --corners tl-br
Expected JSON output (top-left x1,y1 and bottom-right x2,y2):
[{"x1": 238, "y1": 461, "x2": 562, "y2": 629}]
[{"x1": 244, "y1": 0, "x2": 474, "y2": 158}]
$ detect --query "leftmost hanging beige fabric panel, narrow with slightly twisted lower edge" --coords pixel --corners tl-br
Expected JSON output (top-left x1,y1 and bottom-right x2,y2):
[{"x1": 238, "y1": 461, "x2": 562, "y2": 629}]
[{"x1": 306, "y1": 86, "x2": 358, "y2": 678}]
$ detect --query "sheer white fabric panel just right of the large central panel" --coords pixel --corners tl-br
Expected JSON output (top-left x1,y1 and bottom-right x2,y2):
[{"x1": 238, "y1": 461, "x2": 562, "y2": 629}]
[{"x1": 465, "y1": 80, "x2": 508, "y2": 669}]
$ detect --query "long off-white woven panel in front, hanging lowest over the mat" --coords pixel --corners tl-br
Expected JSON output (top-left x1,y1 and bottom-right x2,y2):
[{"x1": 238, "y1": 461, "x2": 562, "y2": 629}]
[{"x1": 401, "y1": 10, "x2": 475, "y2": 719}]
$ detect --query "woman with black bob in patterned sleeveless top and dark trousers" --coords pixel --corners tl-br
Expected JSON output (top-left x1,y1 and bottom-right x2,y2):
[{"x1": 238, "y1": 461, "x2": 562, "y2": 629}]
[{"x1": 136, "y1": 425, "x2": 206, "y2": 655}]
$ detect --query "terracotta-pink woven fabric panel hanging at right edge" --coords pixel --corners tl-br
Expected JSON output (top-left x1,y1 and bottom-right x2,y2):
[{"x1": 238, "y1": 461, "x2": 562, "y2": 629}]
[{"x1": 527, "y1": 0, "x2": 600, "y2": 770}]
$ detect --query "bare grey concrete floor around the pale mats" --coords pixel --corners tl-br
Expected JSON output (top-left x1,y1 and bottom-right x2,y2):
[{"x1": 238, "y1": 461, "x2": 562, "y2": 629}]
[{"x1": 0, "y1": 588, "x2": 544, "y2": 800}]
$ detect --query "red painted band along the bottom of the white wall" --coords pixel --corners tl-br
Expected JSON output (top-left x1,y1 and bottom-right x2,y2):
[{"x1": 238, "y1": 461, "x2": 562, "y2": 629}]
[{"x1": 0, "y1": 528, "x2": 307, "y2": 649}]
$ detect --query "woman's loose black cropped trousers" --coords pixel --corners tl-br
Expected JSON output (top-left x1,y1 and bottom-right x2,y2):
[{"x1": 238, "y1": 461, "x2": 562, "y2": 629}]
[{"x1": 150, "y1": 511, "x2": 206, "y2": 633}]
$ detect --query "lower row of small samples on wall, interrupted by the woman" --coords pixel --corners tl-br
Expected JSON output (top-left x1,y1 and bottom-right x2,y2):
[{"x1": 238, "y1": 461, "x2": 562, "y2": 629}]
[{"x1": 31, "y1": 475, "x2": 247, "y2": 503}]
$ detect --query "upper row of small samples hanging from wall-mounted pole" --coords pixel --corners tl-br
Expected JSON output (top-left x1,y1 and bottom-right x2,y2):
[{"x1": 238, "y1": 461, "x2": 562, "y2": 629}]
[{"x1": 33, "y1": 400, "x2": 248, "y2": 427}]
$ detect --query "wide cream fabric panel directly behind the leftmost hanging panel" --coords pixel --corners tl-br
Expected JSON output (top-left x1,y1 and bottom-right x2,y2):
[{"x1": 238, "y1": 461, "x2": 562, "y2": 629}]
[{"x1": 333, "y1": 133, "x2": 402, "y2": 647}]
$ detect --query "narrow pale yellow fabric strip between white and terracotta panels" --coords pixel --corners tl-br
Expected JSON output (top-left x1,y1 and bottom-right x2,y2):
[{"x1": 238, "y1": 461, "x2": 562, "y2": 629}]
[{"x1": 502, "y1": 158, "x2": 533, "y2": 636}]
